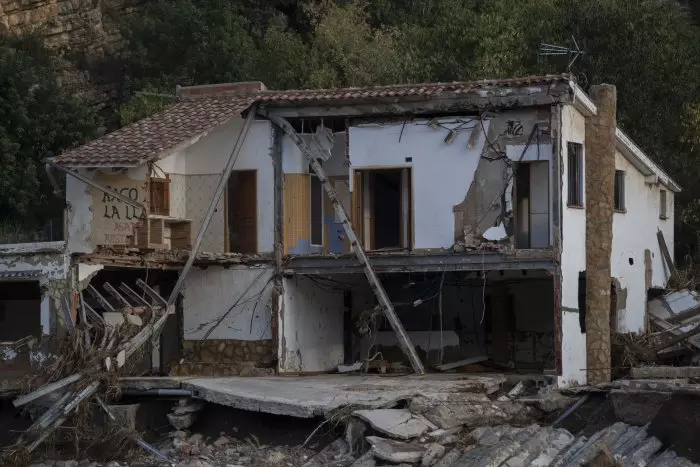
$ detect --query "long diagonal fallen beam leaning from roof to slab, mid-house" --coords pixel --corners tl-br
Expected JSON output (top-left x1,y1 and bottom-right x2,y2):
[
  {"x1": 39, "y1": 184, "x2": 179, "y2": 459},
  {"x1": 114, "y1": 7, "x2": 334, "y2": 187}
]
[{"x1": 258, "y1": 109, "x2": 425, "y2": 375}]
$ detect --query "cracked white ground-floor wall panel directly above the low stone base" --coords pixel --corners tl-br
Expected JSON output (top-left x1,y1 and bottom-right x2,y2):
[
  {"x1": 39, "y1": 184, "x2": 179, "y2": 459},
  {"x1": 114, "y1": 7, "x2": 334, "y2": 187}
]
[{"x1": 183, "y1": 267, "x2": 273, "y2": 341}]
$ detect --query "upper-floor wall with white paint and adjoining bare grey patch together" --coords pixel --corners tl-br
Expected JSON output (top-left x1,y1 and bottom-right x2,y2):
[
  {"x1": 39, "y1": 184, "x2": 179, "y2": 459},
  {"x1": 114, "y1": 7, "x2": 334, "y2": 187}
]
[{"x1": 349, "y1": 109, "x2": 551, "y2": 249}]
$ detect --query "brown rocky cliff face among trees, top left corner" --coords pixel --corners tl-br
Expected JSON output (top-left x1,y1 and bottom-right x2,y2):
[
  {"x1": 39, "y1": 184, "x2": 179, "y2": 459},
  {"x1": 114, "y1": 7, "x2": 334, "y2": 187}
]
[{"x1": 0, "y1": 0, "x2": 143, "y2": 105}]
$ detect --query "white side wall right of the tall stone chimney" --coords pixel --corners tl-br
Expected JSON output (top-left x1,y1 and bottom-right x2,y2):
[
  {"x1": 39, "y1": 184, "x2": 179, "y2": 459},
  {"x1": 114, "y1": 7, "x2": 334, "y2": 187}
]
[{"x1": 610, "y1": 152, "x2": 674, "y2": 332}]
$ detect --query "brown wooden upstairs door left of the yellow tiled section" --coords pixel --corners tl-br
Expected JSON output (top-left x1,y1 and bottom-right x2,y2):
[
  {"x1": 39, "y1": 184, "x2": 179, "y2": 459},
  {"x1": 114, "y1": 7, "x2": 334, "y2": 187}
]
[{"x1": 226, "y1": 170, "x2": 258, "y2": 254}]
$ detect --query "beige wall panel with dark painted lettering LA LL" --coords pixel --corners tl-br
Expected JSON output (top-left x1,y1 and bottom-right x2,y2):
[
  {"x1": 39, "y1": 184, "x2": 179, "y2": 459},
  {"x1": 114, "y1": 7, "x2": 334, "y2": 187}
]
[{"x1": 92, "y1": 173, "x2": 148, "y2": 245}]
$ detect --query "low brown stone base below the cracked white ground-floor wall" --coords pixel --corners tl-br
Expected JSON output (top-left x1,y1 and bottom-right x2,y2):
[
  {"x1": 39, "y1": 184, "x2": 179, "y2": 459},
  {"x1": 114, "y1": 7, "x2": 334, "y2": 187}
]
[{"x1": 170, "y1": 339, "x2": 277, "y2": 376}]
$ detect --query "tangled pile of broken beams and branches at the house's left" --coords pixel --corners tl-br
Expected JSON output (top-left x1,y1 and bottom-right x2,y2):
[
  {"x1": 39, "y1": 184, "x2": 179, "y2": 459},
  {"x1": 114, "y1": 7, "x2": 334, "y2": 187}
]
[{"x1": 0, "y1": 280, "x2": 169, "y2": 465}]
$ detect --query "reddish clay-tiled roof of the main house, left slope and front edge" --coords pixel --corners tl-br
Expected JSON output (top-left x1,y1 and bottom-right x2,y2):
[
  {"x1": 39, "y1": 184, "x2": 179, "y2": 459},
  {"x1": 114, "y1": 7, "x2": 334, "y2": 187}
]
[{"x1": 54, "y1": 74, "x2": 571, "y2": 167}]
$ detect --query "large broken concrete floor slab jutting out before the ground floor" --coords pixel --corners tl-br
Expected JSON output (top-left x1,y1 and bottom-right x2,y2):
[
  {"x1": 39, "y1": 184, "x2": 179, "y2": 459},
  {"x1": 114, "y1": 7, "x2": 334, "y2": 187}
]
[{"x1": 181, "y1": 375, "x2": 505, "y2": 418}]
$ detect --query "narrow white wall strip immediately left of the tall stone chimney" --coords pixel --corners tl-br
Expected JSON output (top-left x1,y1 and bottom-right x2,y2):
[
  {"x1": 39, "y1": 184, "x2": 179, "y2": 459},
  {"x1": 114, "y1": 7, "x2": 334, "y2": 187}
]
[{"x1": 559, "y1": 105, "x2": 586, "y2": 386}]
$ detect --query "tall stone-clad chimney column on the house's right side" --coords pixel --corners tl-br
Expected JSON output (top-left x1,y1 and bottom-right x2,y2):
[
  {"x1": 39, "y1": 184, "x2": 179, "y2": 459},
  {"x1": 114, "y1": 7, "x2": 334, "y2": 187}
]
[{"x1": 585, "y1": 84, "x2": 617, "y2": 384}]
